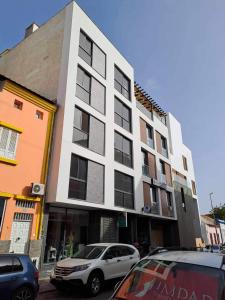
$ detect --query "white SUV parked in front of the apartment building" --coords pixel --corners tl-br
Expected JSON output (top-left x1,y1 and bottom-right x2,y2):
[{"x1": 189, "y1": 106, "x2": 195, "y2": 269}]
[{"x1": 50, "y1": 243, "x2": 140, "y2": 296}]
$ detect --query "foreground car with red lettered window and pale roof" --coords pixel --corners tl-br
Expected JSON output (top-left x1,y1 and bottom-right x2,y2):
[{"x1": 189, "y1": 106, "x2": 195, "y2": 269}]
[{"x1": 110, "y1": 250, "x2": 225, "y2": 300}]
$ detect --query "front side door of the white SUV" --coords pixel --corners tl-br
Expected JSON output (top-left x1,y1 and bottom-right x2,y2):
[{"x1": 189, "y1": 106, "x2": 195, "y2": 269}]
[{"x1": 102, "y1": 246, "x2": 120, "y2": 279}]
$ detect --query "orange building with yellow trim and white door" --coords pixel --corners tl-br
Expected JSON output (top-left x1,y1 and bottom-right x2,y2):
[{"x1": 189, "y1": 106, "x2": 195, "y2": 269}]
[{"x1": 0, "y1": 76, "x2": 56, "y2": 257}]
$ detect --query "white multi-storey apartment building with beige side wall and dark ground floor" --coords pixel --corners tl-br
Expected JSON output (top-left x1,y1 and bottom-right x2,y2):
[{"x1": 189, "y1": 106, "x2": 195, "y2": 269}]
[{"x1": 0, "y1": 2, "x2": 201, "y2": 262}]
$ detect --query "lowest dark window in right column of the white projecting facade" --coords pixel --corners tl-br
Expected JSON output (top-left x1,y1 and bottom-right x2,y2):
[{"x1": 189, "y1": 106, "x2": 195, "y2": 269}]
[{"x1": 115, "y1": 171, "x2": 134, "y2": 209}]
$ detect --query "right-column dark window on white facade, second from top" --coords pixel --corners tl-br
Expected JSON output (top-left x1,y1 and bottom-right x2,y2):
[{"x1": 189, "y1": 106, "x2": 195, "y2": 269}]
[{"x1": 114, "y1": 98, "x2": 131, "y2": 131}]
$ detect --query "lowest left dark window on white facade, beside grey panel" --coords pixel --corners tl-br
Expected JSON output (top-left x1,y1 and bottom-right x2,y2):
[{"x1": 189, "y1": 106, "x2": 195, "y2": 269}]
[{"x1": 68, "y1": 154, "x2": 87, "y2": 200}]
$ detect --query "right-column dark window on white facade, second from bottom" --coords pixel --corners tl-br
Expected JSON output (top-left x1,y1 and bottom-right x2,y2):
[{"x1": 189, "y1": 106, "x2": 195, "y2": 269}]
[{"x1": 114, "y1": 132, "x2": 132, "y2": 167}]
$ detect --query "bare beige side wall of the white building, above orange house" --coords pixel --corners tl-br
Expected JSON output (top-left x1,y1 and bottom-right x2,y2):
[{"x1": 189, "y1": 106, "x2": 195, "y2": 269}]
[{"x1": 0, "y1": 9, "x2": 65, "y2": 100}]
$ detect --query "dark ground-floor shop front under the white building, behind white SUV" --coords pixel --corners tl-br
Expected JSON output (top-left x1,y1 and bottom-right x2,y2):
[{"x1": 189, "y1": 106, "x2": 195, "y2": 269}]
[{"x1": 44, "y1": 206, "x2": 179, "y2": 263}]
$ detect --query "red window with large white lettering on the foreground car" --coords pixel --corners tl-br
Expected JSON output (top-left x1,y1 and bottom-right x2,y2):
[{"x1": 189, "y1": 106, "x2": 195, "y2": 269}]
[{"x1": 112, "y1": 259, "x2": 224, "y2": 300}]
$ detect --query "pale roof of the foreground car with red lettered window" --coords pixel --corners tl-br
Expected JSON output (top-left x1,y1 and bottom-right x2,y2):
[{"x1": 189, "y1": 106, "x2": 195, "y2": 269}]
[{"x1": 147, "y1": 251, "x2": 224, "y2": 268}]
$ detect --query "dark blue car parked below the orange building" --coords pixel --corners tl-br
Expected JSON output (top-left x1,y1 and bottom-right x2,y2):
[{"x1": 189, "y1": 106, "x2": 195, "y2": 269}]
[{"x1": 0, "y1": 254, "x2": 39, "y2": 300}]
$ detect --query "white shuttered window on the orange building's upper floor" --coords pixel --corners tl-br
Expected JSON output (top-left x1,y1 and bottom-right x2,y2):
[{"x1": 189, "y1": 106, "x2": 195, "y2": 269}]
[{"x1": 0, "y1": 126, "x2": 19, "y2": 160}]
